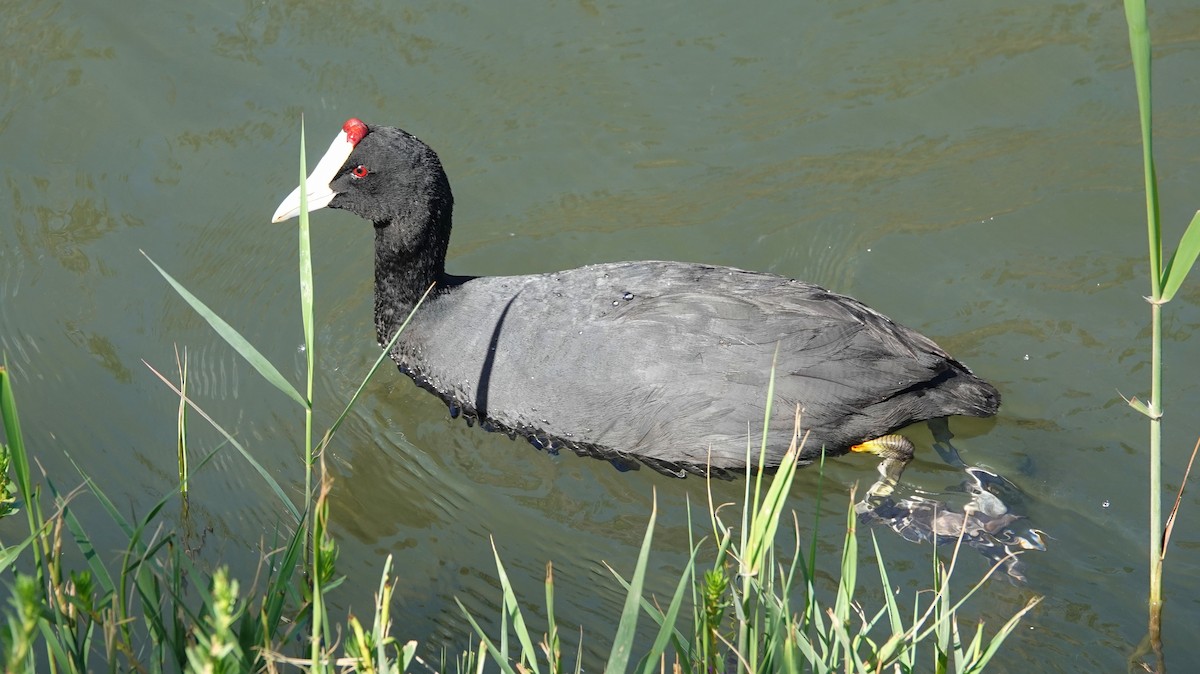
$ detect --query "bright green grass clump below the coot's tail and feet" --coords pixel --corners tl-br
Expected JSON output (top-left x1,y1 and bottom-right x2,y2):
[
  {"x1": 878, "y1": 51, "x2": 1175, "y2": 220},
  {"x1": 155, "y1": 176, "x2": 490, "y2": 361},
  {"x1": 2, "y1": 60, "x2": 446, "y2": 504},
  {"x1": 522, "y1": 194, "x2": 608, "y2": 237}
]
[{"x1": 460, "y1": 402, "x2": 1040, "y2": 674}]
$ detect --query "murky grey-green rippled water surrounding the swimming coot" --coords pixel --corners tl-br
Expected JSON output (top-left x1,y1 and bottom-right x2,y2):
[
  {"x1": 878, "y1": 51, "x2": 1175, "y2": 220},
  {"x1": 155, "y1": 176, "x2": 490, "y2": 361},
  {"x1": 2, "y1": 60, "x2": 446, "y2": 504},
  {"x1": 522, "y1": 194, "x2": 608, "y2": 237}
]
[{"x1": 0, "y1": 0, "x2": 1200, "y2": 672}]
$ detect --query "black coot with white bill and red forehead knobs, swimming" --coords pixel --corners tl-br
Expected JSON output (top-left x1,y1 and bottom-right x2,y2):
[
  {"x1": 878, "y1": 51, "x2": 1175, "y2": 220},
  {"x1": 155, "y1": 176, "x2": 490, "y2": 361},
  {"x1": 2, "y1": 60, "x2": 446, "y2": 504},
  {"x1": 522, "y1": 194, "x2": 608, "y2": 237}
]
[{"x1": 274, "y1": 119, "x2": 1000, "y2": 477}]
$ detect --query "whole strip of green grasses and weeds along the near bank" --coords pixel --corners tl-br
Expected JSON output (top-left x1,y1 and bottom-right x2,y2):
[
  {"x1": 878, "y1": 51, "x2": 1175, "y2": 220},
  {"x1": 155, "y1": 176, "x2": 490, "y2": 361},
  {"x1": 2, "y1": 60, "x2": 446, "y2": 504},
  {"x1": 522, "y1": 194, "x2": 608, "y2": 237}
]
[{"x1": 0, "y1": 128, "x2": 1040, "y2": 674}]
